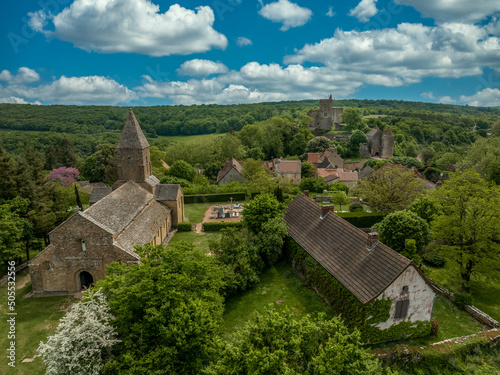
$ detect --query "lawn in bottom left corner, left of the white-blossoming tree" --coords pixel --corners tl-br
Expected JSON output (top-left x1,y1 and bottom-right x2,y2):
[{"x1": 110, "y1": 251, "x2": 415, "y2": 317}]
[{"x1": 0, "y1": 270, "x2": 77, "y2": 375}]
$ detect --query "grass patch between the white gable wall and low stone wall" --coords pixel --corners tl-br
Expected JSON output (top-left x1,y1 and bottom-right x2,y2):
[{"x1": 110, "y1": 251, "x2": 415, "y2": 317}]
[{"x1": 372, "y1": 296, "x2": 483, "y2": 348}]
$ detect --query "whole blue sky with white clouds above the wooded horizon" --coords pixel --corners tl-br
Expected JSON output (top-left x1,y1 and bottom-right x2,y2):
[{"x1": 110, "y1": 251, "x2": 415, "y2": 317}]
[{"x1": 0, "y1": 0, "x2": 500, "y2": 106}]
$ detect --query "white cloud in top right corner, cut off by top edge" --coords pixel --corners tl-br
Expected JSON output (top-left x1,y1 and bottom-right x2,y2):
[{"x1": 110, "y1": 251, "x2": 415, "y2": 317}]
[{"x1": 394, "y1": 0, "x2": 500, "y2": 22}]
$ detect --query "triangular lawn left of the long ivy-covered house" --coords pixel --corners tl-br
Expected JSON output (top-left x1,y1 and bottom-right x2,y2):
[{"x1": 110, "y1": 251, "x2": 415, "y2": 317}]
[{"x1": 222, "y1": 260, "x2": 333, "y2": 335}]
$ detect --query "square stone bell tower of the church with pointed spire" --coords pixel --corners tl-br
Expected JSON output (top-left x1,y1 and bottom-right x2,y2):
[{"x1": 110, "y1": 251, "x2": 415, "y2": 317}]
[{"x1": 113, "y1": 108, "x2": 151, "y2": 190}]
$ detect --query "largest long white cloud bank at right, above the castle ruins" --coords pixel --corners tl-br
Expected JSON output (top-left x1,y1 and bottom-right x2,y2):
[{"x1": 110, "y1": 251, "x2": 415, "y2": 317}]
[{"x1": 285, "y1": 23, "x2": 500, "y2": 86}]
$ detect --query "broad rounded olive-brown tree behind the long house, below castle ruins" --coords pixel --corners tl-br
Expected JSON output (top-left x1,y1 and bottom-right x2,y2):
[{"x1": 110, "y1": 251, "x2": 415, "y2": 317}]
[{"x1": 354, "y1": 163, "x2": 424, "y2": 212}]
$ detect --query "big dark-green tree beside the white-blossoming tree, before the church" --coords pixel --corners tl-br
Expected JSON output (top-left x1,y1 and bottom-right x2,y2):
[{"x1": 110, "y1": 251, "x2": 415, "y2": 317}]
[{"x1": 96, "y1": 242, "x2": 223, "y2": 374}]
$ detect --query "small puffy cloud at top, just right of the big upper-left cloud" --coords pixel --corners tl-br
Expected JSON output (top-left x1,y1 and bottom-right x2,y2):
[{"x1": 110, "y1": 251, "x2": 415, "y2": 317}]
[{"x1": 259, "y1": 0, "x2": 312, "y2": 31}]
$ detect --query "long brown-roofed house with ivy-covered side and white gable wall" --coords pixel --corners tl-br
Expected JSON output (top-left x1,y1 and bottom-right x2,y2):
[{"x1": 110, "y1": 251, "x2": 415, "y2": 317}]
[{"x1": 285, "y1": 194, "x2": 435, "y2": 341}]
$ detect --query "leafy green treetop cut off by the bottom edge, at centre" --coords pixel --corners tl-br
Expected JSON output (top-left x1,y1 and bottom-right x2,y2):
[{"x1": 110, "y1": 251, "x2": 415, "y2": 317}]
[{"x1": 205, "y1": 309, "x2": 391, "y2": 375}]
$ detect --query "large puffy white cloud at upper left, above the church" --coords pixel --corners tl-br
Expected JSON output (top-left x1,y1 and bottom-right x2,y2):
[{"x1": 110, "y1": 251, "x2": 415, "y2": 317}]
[{"x1": 28, "y1": 0, "x2": 227, "y2": 56}]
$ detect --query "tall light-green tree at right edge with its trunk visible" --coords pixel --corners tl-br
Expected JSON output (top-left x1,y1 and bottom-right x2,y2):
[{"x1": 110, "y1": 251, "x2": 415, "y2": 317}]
[{"x1": 432, "y1": 169, "x2": 500, "y2": 290}]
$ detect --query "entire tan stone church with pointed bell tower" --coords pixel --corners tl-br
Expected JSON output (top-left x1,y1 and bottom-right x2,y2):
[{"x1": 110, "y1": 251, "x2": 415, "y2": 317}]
[{"x1": 29, "y1": 110, "x2": 184, "y2": 296}]
